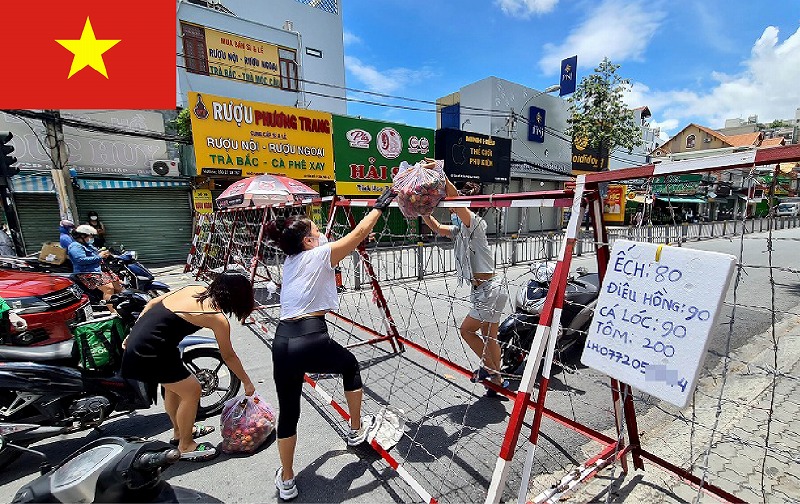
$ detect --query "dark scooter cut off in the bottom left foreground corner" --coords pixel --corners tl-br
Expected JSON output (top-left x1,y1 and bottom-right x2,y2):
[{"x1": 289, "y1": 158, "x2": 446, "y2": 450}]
[{"x1": 0, "y1": 435, "x2": 180, "y2": 503}]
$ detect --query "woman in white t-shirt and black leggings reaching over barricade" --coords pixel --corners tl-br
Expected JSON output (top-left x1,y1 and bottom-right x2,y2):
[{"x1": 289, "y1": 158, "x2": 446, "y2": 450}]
[{"x1": 267, "y1": 188, "x2": 395, "y2": 500}]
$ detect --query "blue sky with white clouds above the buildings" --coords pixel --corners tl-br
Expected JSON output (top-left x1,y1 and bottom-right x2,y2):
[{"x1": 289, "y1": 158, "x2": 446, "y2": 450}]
[{"x1": 342, "y1": 0, "x2": 800, "y2": 135}]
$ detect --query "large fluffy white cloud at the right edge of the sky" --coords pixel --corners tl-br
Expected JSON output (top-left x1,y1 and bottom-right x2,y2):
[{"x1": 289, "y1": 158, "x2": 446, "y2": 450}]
[{"x1": 626, "y1": 26, "x2": 800, "y2": 133}]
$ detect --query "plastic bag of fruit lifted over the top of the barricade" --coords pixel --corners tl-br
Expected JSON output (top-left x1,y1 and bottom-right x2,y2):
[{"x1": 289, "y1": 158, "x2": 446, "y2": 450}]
[{"x1": 392, "y1": 160, "x2": 445, "y2": 219}]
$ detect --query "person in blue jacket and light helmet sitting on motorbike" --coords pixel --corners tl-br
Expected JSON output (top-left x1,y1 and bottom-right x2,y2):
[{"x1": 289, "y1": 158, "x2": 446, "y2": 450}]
[{"x1": 67, "y1": 224, "x2": 122, "y2": 312}]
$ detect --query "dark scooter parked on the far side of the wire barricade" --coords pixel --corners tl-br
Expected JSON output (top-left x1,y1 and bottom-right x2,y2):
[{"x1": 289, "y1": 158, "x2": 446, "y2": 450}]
[{"x1": 497, "y1": 262, "x2": 600, "y2": 375}]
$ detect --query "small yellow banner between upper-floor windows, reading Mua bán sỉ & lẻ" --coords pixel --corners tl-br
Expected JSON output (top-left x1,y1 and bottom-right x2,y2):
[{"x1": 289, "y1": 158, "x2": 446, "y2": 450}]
[{"x1": 205, "y1": 28, "x2": 281, "y2": 87}]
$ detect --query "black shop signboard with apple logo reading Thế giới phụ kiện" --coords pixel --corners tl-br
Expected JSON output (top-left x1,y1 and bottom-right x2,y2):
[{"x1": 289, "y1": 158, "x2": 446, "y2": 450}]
[{"x1": 436, "y1": 128, "x2": 511, "y2": 184}]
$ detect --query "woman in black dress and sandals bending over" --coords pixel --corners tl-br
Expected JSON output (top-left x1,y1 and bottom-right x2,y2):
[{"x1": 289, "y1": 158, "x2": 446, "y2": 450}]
[{"x1": 122, "y1": 272, "x2": 255, "y2": 461}]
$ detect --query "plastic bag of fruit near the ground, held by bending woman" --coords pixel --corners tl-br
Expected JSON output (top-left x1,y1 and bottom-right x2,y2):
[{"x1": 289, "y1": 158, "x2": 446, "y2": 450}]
[{"x1": 220, "y1": 394, "x2": 275, "y2": 453}]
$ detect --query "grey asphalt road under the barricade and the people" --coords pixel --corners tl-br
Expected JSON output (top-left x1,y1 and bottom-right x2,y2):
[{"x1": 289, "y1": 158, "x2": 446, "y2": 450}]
[{"x1": 0, "y1": 230, "x2": 800, "y2": 502}]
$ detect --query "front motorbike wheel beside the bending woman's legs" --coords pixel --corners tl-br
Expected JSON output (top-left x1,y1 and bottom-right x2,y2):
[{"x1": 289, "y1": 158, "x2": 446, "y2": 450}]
[{"x1": 183, "y1": 348, "x2": 242, "y2": 420}]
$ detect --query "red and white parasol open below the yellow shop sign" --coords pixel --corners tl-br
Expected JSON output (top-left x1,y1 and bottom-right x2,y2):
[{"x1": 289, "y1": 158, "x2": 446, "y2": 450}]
[{"x1": 217, "y1": 175, "x2": 319, "y2": 208}]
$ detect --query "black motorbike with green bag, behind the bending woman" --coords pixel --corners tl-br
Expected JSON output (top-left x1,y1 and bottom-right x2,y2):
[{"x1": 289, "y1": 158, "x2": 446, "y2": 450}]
[{"x1": 0, "y1": 290, "x2": 241, "y2": 467}]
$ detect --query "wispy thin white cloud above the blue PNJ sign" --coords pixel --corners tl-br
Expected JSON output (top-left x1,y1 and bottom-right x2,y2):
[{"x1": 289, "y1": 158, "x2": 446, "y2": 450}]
[{"x1": 539, "y1": 0, "x2": 664, "y2": 75}]
